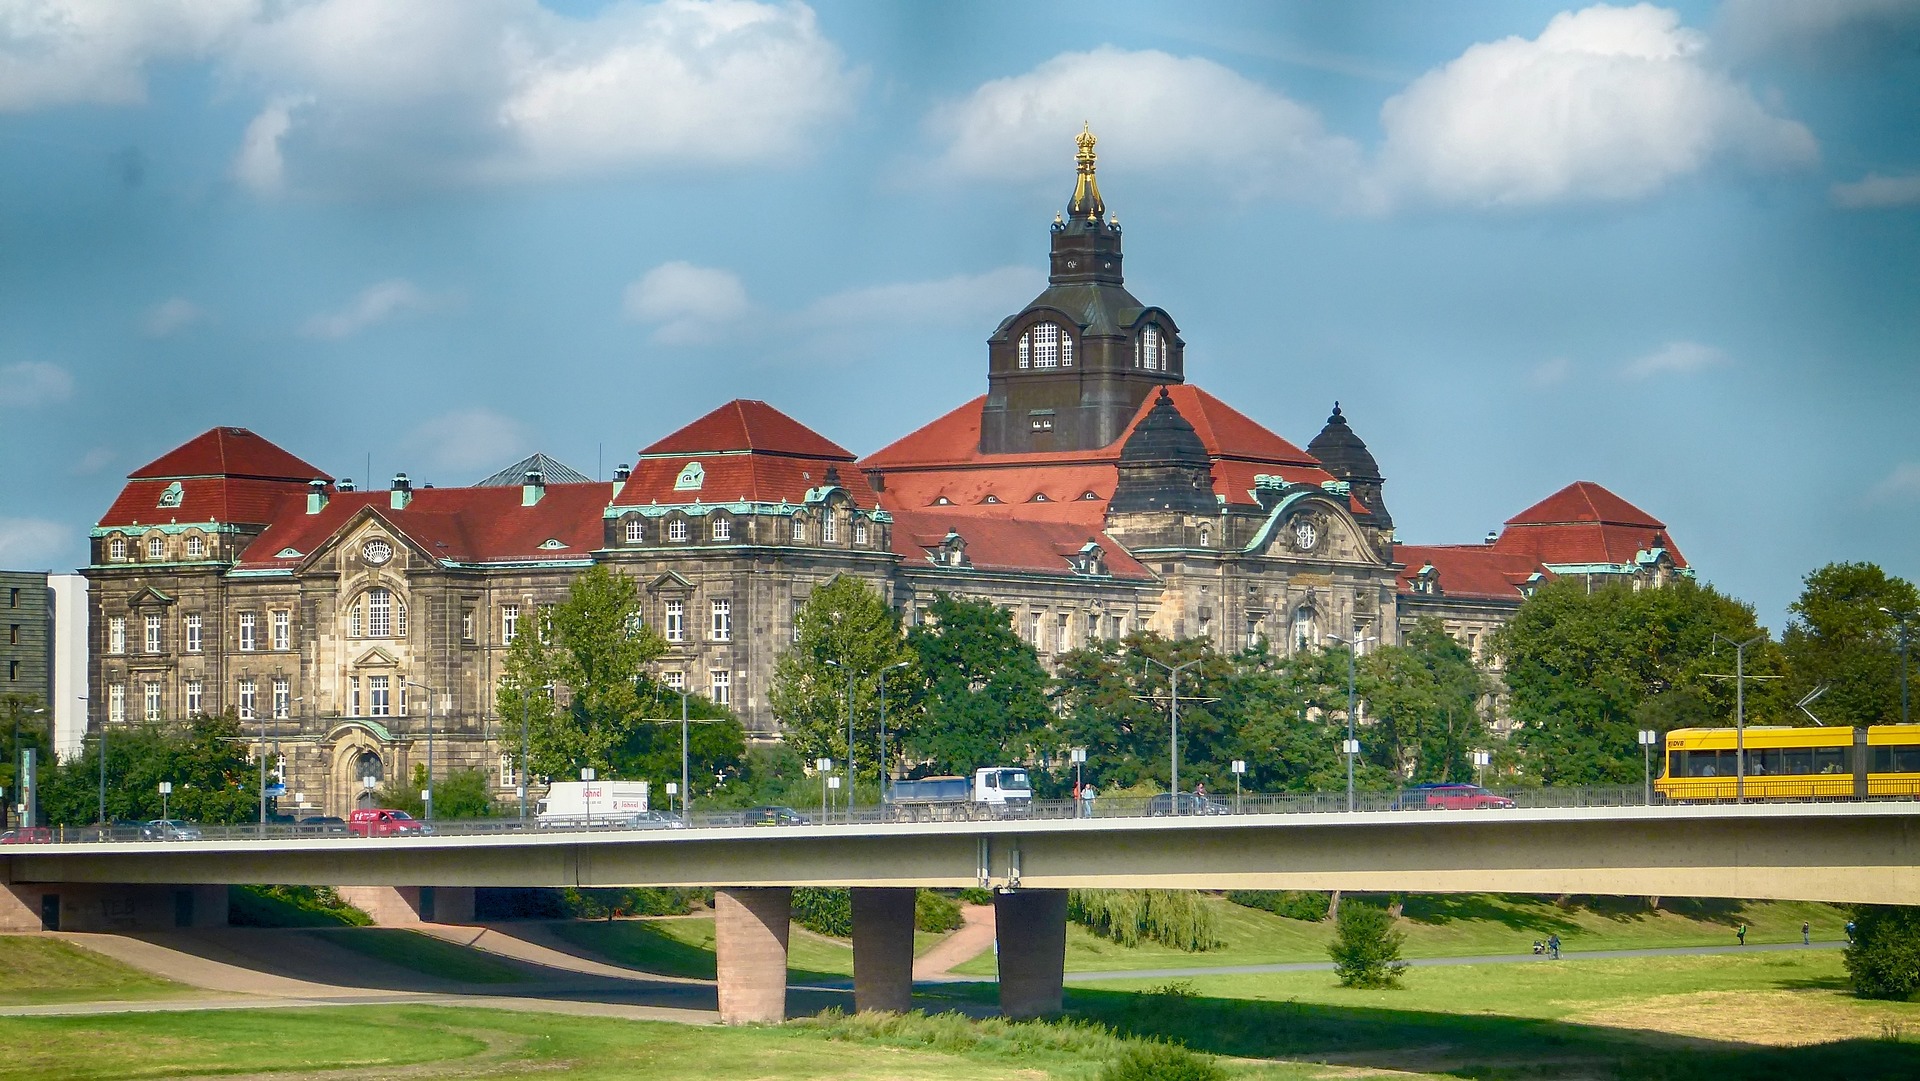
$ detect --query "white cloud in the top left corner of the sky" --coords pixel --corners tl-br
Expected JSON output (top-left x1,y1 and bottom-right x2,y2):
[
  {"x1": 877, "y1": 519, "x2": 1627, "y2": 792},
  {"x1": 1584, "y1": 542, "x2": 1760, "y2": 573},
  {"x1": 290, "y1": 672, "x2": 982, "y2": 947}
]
[{"x1": 0, "y1": 0, "x2": 261, "y2": 111}]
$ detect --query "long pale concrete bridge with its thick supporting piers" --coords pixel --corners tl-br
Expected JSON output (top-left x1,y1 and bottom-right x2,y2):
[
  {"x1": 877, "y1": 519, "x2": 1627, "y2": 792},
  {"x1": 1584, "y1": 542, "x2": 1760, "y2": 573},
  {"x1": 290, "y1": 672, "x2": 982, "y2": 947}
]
[{"x1": 0, "y1": 801, "x2": 1920, "y2": 1021}]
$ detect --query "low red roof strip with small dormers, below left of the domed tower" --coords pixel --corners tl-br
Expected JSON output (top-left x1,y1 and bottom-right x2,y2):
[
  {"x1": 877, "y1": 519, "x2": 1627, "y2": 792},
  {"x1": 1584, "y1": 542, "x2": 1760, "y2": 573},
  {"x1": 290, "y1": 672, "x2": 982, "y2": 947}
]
[{"x1": 891, "y1": 507, "x2": 1152, "y2": 580}]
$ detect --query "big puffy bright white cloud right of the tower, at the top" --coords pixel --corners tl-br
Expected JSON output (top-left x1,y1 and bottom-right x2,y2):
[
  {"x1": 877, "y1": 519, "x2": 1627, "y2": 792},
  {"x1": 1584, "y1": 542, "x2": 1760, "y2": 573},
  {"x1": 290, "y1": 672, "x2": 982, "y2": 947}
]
[{"x1": 1379, "y1": 4, "x2": 1818, "y2": 207}]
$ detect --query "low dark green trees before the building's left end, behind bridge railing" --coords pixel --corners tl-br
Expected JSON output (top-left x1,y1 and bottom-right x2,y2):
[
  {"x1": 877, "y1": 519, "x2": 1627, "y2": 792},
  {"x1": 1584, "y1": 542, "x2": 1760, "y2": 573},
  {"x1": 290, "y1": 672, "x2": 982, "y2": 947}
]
[{"x1": 40, "y1": 712, "x2": 259, "y2": 826}]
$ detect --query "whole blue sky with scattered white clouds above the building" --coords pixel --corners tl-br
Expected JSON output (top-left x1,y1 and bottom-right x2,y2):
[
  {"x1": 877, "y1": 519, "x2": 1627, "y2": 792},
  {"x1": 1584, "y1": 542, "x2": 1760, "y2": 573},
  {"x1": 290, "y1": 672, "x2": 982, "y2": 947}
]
[{"x1": 0, "y1": 0, "x2": 1920, "y2": 630}]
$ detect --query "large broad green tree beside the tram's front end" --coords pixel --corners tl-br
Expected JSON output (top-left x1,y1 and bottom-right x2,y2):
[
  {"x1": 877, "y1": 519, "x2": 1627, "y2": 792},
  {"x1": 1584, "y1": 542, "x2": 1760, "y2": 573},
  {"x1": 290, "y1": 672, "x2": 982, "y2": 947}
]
[{"x1": 1490, "y1": 578, "x2": 1791, "y2": 785}]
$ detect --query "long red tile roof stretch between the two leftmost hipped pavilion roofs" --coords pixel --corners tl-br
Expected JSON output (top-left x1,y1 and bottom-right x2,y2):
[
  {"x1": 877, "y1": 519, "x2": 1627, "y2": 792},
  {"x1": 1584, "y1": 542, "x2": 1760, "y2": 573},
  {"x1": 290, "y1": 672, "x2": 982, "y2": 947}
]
[{"x1": 240, "y1": 482, "x2": 612, "y2": 570}]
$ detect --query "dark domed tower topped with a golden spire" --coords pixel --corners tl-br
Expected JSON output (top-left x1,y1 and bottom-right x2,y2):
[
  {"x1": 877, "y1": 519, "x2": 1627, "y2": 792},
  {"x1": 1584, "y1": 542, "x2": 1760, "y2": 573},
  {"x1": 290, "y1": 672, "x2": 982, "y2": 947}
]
[{"x1": 979, "y1": 131, "x2": 1185, "y2": 453}]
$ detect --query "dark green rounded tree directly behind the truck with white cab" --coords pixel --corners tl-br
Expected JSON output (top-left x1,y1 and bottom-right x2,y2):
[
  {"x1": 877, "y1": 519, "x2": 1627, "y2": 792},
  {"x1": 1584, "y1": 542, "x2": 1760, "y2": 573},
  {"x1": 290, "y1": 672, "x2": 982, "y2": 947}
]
[{"x1": 889, "y1": 593, "x2": 1052, "y2": 776}]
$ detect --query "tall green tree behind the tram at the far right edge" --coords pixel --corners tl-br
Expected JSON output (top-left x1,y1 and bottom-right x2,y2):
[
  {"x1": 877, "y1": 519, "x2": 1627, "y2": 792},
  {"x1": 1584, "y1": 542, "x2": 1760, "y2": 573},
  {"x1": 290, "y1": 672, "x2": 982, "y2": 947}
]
[{"x1": 1780, "y1": 563, "x2": 1920, "y2": 728}]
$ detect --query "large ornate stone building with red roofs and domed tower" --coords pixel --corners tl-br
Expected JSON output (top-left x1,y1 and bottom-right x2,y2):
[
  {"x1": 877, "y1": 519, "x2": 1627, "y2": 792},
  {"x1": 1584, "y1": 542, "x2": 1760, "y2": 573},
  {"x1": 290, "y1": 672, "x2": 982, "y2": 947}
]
[{"x1": 86, "y1": 134, "x2": 1686, "y2": 812}]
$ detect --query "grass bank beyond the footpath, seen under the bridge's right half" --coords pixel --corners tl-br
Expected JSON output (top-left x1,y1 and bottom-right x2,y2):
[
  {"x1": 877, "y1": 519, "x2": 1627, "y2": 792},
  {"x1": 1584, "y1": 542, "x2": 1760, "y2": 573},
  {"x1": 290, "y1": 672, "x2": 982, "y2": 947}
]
[{"x1": 954, "y1": 893, "x2": 1847, "y2": 975}]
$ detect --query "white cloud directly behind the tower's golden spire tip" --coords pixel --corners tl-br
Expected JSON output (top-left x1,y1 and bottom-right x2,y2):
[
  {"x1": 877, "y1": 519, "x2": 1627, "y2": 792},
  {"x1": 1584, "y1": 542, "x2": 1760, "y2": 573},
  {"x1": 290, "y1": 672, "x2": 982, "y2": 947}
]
[{"x1": 927, "y1": 48, "x2": 1361, "y2": 198}]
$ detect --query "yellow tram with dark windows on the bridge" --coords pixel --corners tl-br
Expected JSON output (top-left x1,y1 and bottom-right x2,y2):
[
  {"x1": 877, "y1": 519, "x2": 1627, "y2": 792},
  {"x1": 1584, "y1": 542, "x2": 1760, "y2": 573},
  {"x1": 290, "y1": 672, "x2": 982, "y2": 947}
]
[{"x1": 1653, "y1": 724, "x2": 1920, "y2": 801}]
